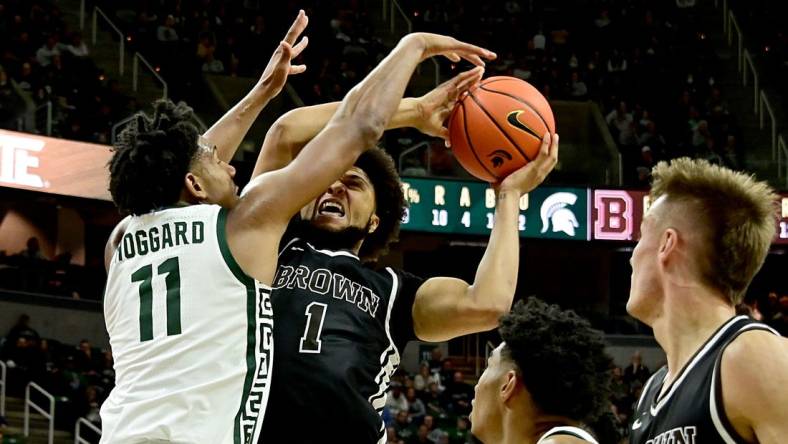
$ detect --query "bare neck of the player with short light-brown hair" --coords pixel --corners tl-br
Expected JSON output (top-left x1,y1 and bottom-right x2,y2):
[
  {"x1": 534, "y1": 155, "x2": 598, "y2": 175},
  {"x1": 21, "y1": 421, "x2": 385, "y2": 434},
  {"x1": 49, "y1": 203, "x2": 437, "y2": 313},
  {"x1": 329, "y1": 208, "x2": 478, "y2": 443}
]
[{"x1": 653, "y1": 288, "x2": 736, "y2": 386}]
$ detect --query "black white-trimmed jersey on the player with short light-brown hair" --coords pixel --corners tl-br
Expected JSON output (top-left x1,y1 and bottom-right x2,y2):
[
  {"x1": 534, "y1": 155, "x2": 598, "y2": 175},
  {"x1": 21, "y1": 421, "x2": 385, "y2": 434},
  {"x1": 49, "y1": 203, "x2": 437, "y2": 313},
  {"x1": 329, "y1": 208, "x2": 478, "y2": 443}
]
[{"x1": 630, "y1": 316, "x2": 777, "y2": 444}]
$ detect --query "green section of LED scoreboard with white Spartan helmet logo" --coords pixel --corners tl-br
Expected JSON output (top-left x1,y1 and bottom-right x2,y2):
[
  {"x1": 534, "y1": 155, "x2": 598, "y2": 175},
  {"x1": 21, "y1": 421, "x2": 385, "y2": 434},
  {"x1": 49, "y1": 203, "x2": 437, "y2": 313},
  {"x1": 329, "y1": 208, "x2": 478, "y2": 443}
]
[{"x1": 402, "y1": 178, "x2": 590, "y2": 240}]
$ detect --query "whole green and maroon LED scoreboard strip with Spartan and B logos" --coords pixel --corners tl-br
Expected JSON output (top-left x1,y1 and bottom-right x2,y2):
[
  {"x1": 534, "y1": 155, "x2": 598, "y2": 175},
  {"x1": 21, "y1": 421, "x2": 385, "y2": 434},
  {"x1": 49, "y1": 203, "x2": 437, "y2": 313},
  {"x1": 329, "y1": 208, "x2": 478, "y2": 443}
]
[{"x1": 402, "y1": 178, "x2": 788, "y2": 244}]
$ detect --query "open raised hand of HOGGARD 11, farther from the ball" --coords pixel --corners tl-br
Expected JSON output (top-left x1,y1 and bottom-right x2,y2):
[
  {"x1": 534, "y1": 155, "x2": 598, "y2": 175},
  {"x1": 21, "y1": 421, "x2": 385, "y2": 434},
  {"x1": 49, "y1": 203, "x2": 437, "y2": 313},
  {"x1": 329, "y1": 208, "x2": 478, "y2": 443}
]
[{"x1": 259, "y1": 9, "x2": 309, "y2": 98}]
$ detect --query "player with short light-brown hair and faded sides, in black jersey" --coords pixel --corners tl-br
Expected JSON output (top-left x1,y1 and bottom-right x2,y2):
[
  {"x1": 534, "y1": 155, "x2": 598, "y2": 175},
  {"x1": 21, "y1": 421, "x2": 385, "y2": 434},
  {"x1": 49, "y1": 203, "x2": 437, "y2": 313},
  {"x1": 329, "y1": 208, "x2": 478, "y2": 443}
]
[{"x1": 627, "y1": 158, "x2": 788, "y2": 444}]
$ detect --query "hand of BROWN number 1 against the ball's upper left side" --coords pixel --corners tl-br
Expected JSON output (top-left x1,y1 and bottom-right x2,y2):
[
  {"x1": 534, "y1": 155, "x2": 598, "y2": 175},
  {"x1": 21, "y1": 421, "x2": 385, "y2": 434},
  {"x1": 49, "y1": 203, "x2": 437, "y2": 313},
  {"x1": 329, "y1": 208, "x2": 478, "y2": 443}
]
[{"x1": 415, "y1": 66, "x2": 484, "y2": 146}]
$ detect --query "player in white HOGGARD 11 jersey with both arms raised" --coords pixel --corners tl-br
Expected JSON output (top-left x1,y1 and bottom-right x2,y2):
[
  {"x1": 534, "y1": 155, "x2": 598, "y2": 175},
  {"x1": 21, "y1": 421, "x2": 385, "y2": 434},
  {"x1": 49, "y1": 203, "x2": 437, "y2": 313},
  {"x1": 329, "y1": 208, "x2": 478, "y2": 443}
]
[{"x1": 101, "y1": 5, "x2": 487, "y2": 438}]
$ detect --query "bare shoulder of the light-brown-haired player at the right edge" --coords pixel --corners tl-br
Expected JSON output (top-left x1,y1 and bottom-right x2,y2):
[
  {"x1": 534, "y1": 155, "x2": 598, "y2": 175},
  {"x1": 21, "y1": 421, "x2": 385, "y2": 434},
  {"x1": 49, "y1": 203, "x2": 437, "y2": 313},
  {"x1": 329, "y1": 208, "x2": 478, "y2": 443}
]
[{"x1": 720, "y1": 330, "x2": 788, "y2": 444}]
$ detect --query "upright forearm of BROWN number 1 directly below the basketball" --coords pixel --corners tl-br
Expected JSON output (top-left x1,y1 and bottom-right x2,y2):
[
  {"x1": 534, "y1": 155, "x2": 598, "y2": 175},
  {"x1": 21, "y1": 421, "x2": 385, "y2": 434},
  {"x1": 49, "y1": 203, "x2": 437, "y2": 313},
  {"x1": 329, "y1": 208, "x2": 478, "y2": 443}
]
[{"x1": 472, "y1": 190, "x2": 520, "y2": 316}]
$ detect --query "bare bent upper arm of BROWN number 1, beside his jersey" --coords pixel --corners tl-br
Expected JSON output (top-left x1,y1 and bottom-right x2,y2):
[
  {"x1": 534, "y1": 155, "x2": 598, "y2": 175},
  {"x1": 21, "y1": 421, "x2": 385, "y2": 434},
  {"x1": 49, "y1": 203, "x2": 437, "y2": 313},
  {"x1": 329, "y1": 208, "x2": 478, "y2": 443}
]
[{"x1": 413, "y1": 277, "x2": 504, "y2": 342}]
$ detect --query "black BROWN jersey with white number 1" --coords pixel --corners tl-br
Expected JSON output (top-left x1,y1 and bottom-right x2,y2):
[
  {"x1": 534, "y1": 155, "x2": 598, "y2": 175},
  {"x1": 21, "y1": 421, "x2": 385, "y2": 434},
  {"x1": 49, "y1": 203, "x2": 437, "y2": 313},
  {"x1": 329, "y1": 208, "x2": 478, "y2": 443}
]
[{"x1": 259, "y1": 238, "x2": 422, "y2": 444}]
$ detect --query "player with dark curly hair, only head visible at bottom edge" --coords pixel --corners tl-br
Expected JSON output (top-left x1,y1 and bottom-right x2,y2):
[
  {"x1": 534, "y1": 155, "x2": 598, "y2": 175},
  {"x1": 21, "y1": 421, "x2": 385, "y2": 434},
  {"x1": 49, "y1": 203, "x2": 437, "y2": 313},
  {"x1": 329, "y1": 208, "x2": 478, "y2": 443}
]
[{"x1": 471, "y1": 297, "x2": 611, "y2": 444}]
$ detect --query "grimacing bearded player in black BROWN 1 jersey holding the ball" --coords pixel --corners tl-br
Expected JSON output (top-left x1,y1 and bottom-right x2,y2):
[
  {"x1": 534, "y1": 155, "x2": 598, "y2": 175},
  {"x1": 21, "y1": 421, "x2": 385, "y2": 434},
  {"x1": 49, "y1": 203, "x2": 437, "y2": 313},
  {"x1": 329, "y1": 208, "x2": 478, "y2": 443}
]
[{"x1": 255, "y1": 70, "x2": 558, "y2": 443}]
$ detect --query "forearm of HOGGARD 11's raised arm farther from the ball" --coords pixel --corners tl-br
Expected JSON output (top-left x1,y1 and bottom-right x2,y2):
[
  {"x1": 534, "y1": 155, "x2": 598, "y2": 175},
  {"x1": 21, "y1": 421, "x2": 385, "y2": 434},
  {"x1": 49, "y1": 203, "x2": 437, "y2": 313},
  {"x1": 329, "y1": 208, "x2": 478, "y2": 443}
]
[{"x1": 203, "y1": 83, "x2": 271, "y2": 162}]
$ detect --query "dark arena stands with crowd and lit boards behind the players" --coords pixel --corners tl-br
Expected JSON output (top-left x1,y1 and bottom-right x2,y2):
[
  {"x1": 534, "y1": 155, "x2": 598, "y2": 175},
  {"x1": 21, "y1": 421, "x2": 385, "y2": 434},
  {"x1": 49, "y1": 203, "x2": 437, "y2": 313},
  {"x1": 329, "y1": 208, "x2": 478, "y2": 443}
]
[{"x1": 0, "y1": 0, "x2": 788, "y2": 443}]
